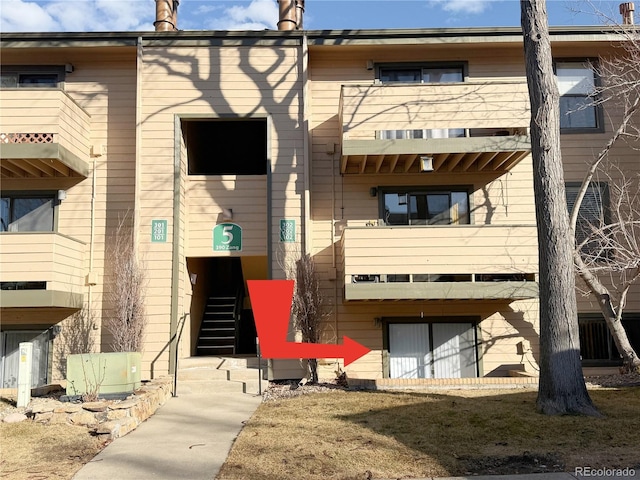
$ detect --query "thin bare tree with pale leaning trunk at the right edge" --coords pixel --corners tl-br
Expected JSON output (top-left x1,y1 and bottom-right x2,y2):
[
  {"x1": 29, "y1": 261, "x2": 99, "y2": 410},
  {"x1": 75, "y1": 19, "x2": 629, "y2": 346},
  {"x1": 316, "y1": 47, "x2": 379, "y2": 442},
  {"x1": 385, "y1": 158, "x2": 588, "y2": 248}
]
[{"x1": 570, "y1": 25, "x2": 640, "y2": 371}]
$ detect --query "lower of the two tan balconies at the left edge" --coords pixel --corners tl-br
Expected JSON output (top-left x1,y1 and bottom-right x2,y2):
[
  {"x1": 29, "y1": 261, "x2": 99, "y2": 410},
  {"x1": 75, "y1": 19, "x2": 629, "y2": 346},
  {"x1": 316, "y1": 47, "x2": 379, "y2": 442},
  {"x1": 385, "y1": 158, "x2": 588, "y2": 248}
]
[{"x1": 0, "y1": 232, "x2": 85, "y2": 316}]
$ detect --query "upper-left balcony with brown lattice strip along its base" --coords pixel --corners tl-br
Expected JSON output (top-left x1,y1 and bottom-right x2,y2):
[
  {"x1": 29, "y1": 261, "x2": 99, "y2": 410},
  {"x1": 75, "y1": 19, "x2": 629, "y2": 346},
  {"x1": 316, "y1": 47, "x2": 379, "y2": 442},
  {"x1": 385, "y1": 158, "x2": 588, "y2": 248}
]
[{"x1": 0, "y1": 88, "x2": 90, "y2": 179}]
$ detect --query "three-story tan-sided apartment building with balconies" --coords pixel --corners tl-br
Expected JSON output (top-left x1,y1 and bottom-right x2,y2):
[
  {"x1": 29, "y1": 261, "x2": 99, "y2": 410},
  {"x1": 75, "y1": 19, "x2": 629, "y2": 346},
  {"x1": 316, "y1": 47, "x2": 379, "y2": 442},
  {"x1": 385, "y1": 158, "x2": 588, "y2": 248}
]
[{"x1": 0, "y1": 12, "x2": 640, "y2": 387}]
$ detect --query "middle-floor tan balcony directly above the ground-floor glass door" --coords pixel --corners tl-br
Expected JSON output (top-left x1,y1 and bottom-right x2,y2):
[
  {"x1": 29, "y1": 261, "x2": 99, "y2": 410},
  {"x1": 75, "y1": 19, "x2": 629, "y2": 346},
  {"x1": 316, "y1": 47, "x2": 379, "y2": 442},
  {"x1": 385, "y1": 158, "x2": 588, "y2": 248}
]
[{"x1": 341, "y1": 225, "x2": 538, "y2": 301}]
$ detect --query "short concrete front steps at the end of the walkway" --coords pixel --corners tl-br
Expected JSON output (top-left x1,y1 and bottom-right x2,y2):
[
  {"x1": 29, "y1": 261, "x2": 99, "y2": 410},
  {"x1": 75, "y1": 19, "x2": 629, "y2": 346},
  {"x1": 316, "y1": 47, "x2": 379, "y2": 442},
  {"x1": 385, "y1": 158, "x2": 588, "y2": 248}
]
[{"x1": 177, "y1": 357, "x2": 268, "y2": 396}]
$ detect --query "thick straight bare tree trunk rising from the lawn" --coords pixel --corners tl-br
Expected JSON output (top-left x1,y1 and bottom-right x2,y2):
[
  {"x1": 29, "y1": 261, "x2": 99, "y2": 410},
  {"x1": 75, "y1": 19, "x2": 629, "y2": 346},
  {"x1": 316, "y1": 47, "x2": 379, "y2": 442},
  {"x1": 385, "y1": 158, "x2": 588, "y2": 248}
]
[{"x1": 520, "y1": 0, "x2": 599, "y2": 415}]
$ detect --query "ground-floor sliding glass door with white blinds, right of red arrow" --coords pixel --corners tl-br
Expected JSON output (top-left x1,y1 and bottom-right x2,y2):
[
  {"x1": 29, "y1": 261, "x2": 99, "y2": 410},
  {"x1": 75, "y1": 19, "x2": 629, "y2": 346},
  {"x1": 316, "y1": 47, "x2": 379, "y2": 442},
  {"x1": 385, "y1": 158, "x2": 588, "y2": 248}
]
[{"x1": 387, "y1": 321, "x2": 478, "y2": 378}]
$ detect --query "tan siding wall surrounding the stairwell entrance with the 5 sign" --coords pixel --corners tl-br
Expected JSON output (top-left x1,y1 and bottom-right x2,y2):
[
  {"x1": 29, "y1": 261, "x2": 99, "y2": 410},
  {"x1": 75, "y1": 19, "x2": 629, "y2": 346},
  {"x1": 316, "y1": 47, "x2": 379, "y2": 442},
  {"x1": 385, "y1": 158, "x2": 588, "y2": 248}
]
[{"x1": 140, "y1": 46, "x2": 304, "y2": 371}]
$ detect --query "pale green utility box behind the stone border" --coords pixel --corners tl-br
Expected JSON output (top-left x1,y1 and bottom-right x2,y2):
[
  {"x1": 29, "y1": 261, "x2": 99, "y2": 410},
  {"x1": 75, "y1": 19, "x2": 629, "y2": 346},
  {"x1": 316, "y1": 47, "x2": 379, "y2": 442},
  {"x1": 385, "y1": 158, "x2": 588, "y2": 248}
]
[{"x1": 67, "y1": 352, "x2": 142, "y2": 395}]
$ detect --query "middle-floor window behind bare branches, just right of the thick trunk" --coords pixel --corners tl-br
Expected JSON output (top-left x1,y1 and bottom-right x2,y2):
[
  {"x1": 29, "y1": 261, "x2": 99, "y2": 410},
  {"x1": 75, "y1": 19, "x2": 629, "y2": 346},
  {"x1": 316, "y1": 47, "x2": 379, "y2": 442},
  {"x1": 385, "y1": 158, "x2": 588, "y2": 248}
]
[{"x1": 565, "y1": 182, "x2": 609, "y2": 256}]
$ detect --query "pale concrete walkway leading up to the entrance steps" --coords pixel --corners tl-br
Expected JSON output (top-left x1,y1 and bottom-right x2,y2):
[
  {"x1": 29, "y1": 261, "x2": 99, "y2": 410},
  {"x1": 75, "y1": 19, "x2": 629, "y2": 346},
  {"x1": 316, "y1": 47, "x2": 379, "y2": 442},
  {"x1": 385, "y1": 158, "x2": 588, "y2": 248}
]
[{"x1": 73, "y1": 387, "x2": 261, "y2": 480}]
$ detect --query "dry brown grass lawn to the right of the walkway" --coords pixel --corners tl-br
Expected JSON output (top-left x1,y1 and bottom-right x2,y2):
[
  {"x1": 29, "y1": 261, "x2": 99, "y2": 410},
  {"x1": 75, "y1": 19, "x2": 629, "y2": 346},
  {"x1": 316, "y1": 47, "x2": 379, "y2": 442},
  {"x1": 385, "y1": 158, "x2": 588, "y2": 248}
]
[{"x1": 218, "y1": 388, "x2": 640, "y2": 480}]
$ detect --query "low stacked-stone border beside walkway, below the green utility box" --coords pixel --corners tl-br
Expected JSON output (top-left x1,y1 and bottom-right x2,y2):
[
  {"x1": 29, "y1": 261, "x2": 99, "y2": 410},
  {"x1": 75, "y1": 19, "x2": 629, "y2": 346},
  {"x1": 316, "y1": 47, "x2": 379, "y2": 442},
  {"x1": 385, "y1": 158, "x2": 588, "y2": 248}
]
[{"x1": 25, "y1": 377, "x2": 173, "y2": 440}]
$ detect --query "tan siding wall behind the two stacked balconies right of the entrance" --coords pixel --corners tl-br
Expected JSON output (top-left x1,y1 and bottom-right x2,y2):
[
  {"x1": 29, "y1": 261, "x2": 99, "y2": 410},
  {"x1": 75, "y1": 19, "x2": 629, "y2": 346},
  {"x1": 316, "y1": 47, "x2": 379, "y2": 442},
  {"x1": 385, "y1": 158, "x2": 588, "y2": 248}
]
[{"x1": 310, "y1": 45, "x2": 538, "y2": 378}]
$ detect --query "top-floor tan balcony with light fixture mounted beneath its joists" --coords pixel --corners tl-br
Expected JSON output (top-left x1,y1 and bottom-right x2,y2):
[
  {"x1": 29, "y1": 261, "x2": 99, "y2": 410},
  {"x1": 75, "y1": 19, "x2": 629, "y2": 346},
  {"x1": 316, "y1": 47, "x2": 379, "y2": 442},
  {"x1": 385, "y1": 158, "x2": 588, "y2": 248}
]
[{"x1": 339, "y1": 82, "x2": 531, "y2": 174}]
